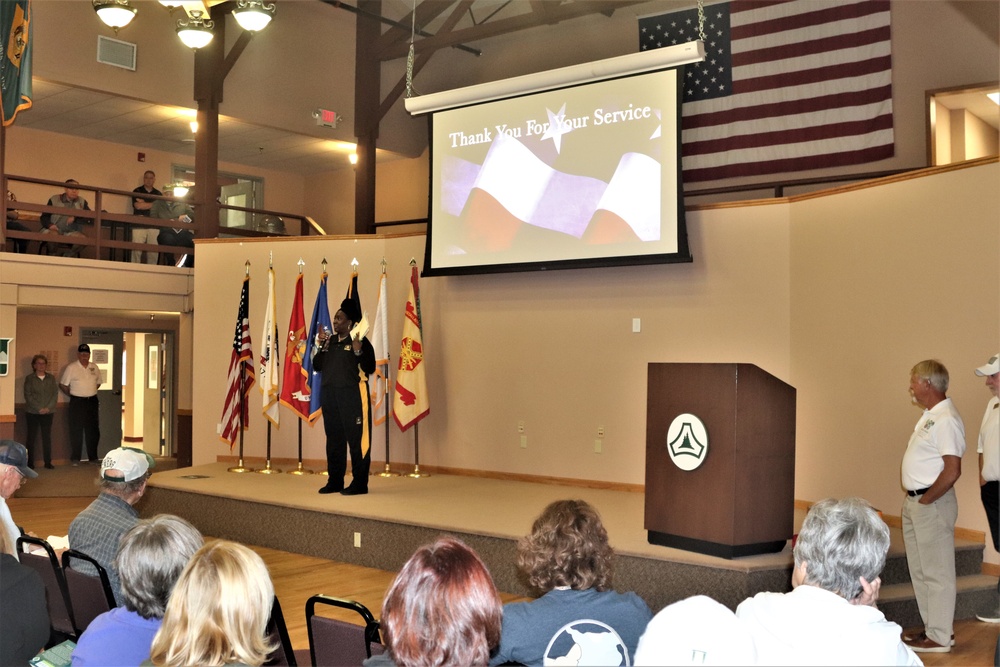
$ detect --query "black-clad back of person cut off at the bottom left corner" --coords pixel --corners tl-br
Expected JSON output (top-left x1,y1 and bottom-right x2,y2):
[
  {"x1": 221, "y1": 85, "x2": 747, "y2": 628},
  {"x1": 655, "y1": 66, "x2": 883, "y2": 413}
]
[{"x1": 0, "y1": 530, "x2": 49, "y2": 665}]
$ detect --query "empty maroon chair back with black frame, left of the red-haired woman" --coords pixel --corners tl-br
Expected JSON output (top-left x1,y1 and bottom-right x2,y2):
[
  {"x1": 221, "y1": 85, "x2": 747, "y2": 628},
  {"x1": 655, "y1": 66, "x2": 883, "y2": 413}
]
[{"x1": 306, "y1": 595, "x2": 385, "y2": 665}]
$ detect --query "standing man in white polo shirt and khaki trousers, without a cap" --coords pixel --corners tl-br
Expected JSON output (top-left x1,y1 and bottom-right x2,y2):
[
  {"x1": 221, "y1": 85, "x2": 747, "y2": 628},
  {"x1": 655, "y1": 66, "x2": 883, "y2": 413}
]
[{"x1": 901, "y1": 359, "x2": 965, "y2": 653}]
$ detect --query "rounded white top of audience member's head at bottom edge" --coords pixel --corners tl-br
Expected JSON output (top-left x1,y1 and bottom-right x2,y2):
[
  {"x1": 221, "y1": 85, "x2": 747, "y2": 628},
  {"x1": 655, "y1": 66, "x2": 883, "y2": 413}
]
[{"x1": 634, "y1": 595, "x2": 757, "y2": 666}]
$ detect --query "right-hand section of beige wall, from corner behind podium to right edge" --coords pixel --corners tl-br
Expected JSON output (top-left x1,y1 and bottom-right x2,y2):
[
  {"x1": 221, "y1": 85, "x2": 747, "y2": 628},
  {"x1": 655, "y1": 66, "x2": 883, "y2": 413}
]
[{"x1": 791, "y1": 163, "x2": 1000, "y2": 562}]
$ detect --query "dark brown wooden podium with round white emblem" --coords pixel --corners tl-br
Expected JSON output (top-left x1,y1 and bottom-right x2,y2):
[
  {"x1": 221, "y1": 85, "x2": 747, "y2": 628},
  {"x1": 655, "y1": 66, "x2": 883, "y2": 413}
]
[{"x1": 645, "y1": 364, "x2": 795, "y2": 558}]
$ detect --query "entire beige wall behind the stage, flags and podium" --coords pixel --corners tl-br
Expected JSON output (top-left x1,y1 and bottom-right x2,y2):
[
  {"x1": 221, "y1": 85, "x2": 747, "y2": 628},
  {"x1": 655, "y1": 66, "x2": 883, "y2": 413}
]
[{"x1": 193, "y1": 163, "x2": 1000, "y2": 560}]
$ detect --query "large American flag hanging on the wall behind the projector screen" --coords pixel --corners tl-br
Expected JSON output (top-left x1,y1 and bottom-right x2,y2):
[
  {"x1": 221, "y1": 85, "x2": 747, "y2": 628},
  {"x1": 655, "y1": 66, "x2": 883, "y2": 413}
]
[{"x1": 639, "y1": 0, "x2": 893, "y2": 183}]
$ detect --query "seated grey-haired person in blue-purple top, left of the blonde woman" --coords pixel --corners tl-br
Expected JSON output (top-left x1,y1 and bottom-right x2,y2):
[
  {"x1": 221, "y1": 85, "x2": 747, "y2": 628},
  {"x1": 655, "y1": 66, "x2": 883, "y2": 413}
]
[{"x1": 73, "y1": 514, "x2": 204, "y2": 667}]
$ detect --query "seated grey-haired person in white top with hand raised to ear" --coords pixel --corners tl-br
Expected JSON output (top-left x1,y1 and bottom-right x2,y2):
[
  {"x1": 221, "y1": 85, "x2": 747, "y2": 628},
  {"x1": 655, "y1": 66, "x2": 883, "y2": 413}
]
[{"x1": 736, "y1": 498, "x2": 921, "y2": 665}]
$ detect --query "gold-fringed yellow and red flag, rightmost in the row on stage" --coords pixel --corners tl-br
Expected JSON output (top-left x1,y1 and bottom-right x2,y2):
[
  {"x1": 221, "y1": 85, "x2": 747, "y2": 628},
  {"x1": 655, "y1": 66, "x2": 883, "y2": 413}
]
[{"x1": 392, "y1": 266, "x2": 431, "y2": 431}]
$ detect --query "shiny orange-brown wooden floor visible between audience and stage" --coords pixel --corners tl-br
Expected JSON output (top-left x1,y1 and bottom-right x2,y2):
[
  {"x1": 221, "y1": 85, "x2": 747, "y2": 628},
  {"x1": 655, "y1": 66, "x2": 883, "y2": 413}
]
[{"x1": 8, "y1": 497, "x2": 1000, "y2": 667}]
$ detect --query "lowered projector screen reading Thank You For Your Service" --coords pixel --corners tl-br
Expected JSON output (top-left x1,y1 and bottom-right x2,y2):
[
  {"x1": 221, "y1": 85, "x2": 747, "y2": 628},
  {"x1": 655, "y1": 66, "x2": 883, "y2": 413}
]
[{"x1": 424, "y1": 69, "x2": 691, "y2": 275}]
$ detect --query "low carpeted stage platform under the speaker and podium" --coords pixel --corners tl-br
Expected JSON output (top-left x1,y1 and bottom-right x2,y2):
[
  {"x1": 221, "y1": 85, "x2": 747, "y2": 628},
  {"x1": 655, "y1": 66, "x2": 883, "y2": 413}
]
[{"x1": 139, "y1": 463, "x2": 996, "y2": 620}]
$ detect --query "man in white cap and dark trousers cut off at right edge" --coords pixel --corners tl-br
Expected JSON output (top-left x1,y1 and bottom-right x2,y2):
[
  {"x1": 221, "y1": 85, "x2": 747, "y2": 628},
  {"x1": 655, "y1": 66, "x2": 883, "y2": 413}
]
[{"x1": 976, "y1": 354, "x2": 1000, "y2": 623}]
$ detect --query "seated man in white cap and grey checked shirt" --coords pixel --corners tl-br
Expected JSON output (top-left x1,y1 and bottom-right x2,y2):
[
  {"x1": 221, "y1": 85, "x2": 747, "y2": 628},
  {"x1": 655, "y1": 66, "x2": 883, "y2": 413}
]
[{"x1": 69, "y1": 447, "x2": 156, "y2": 604}]
